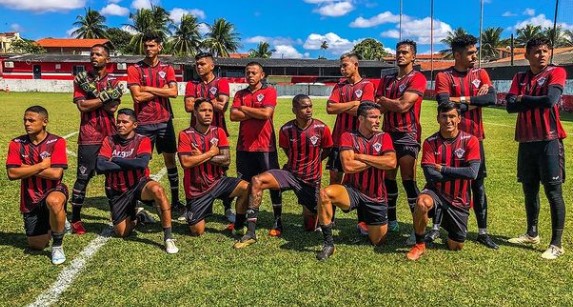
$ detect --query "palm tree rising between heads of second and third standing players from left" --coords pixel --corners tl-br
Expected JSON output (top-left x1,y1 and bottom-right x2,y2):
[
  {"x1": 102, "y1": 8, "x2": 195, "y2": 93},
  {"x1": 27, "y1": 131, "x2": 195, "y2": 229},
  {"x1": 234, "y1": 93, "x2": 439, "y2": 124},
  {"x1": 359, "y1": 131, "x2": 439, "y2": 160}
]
[{"x1": 170, "y1": 14, "x2": 201, "y2": 56}]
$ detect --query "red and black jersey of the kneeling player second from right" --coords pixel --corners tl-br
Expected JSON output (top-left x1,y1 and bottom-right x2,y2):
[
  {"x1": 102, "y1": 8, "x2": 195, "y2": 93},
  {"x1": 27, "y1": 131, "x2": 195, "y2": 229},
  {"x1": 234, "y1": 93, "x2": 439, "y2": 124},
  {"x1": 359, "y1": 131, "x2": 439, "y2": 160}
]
[{"x1": 340, "y1": 131, "x2": 394, "y2": 204}]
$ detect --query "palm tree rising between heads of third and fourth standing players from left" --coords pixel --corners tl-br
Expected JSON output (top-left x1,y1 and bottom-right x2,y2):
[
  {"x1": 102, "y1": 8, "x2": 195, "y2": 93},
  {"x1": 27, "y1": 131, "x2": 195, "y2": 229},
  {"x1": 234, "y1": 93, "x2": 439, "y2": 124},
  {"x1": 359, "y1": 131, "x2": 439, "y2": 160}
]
[{"x1": 203, "y1": 18, "x2": 240, "y2": 57}]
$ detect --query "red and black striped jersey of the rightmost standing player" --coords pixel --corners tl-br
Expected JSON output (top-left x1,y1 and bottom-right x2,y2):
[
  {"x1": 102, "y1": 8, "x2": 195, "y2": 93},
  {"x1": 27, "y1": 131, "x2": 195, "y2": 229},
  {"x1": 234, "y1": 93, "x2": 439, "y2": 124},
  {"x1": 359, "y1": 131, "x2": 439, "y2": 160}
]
[{"x1": 509, "y1": 66, "x2": 567, "y2": 142}]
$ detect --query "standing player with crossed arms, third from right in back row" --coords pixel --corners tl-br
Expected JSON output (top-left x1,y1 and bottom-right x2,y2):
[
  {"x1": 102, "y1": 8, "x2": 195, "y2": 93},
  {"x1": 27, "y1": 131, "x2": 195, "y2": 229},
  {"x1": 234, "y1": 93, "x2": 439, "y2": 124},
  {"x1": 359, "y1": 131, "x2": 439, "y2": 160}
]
[{"x1": 376, "y1": 40, "x2": 426, "y2": 244}]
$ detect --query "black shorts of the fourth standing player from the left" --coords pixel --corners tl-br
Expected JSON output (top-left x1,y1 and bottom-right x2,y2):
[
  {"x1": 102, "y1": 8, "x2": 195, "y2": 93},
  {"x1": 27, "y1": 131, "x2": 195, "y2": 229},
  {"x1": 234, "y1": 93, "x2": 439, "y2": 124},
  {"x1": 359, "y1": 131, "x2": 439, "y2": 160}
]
[{"x1": 237, "y1": 150, "x2": 280, "y2": 182}]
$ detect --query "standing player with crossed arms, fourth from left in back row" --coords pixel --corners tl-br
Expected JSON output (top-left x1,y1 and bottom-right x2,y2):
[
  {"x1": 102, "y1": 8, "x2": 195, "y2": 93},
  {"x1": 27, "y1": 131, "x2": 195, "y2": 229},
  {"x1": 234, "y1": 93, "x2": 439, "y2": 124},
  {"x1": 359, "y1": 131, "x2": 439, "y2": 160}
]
[{"x1": 231, "y1": 62, "x2": 282, "y2": 237}]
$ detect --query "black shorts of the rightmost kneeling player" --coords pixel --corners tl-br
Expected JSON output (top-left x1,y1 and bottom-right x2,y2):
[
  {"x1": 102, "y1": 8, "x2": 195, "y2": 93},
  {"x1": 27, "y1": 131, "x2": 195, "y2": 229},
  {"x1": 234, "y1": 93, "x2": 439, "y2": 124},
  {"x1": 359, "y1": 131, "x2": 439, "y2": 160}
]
[{"x1": 420, "y1": 189, "x2": 470, "y2": 243}]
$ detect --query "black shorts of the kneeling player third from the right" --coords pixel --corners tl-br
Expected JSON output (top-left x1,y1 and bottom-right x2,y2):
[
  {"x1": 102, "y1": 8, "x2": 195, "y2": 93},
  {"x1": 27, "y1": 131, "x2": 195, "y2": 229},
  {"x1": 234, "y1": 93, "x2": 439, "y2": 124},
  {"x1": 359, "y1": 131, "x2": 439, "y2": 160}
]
[{"x1": 269, "y1": 169, "x2": 320, "y2": 213}]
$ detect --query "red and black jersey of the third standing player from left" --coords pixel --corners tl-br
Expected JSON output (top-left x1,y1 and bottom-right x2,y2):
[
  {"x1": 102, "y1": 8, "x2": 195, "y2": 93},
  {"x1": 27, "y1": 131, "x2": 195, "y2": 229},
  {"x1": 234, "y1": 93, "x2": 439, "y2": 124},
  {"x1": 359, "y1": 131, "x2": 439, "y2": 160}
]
[{"x1": 185, "y1": 77, "x2": 229, "y2": 136}]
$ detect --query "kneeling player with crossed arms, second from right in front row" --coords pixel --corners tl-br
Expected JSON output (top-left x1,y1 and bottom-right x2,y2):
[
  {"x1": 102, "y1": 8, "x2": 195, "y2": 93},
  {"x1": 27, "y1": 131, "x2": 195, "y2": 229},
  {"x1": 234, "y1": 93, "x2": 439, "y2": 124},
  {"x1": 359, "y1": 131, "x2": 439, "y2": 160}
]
[{"x1": 316, "y1": 102, "x2": 396, "y2": 260}]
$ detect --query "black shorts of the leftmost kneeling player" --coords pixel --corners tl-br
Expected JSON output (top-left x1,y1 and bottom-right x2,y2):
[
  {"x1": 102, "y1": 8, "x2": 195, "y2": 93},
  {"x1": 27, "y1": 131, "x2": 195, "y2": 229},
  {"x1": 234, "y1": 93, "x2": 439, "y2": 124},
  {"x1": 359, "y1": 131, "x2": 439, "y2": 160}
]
[{"x1": 22, "y1": 184, "x2": 68, "y2": 237}]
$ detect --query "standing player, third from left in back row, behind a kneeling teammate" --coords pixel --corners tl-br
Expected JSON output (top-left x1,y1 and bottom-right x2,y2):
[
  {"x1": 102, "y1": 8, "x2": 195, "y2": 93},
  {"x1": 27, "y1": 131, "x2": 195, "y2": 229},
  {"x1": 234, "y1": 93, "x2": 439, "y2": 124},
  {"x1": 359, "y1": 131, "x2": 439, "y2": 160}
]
[{"x1": 185, "y1": 52, "x2": 235, "y2": 223}]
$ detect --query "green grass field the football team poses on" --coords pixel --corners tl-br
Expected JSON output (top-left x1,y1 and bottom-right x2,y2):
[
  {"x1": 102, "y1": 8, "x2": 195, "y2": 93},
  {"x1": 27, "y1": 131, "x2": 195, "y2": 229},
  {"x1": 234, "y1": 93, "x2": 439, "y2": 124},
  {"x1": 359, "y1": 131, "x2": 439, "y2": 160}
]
[{"x1": 0, "y1": 92, "x2": 573, "y2": 306}]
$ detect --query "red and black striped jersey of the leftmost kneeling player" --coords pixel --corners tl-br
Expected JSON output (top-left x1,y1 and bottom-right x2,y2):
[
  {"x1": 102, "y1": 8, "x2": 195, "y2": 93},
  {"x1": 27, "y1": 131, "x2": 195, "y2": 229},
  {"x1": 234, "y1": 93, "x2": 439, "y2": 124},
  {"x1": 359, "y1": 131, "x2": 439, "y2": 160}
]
[{"x1": 6, "y1": 133, "x2": 68, "y2": 213}]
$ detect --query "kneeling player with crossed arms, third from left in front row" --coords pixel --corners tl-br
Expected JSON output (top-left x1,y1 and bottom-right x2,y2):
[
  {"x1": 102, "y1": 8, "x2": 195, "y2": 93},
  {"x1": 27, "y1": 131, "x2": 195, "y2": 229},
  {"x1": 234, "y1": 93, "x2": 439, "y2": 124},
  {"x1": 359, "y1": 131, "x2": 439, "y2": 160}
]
[{"x1": 177, "y1": 98, "x2": 249, "y2": 236}]
